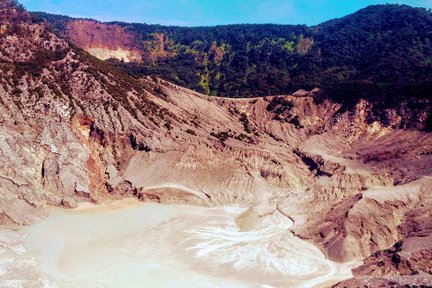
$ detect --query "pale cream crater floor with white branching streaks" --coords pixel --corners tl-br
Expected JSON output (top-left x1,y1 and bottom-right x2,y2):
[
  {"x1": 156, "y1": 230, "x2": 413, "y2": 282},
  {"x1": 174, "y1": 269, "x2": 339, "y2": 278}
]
[{"x1": 0, "y1": 199, "x2": 355, "y2": 288}]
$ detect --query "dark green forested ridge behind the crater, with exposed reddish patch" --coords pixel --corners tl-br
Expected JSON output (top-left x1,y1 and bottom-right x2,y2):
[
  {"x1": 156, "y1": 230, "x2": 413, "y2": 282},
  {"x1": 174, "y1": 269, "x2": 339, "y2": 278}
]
[{"x1": 37, "y1": 5, "x2": 432, "y2": 129}]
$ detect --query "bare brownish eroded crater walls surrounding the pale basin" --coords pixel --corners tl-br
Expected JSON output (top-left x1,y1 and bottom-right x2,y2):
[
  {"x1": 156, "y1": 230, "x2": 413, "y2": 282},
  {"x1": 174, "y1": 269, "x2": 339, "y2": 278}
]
[{"x1": 0, "y1": 1, "x2": 432, "y2": 283}]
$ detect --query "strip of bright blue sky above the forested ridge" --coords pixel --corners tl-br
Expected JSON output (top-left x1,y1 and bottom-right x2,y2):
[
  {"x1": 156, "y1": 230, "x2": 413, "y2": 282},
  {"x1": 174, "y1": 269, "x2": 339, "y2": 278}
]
[{"x1": 20, "y1": 0, "x2": 432, "y2": 26}]
